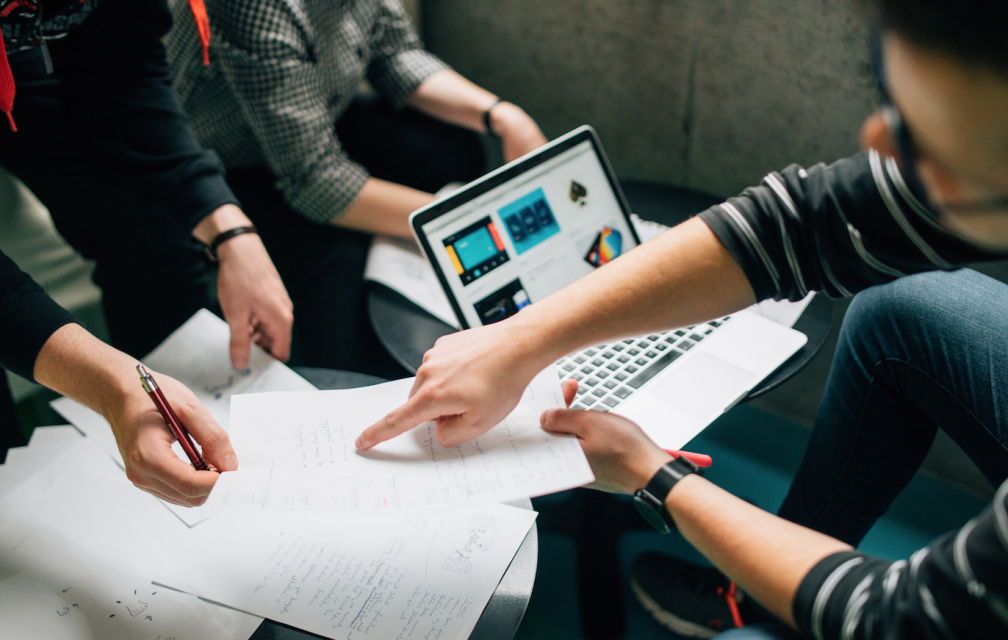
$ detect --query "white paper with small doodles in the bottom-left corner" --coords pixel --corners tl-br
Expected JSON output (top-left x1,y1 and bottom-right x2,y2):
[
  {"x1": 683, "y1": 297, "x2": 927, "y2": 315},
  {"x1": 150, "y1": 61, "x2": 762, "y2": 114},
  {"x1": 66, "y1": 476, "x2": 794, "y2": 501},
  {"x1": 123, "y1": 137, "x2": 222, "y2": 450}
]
[{"x1": 0, "y1": 438, "x2": 262, "y2": 640}]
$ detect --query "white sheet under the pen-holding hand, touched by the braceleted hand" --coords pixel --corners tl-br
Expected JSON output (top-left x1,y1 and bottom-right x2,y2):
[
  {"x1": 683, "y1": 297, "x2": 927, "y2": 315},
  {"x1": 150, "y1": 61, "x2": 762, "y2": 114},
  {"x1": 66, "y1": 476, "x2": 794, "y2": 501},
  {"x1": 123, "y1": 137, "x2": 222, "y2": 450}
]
[{"x1": 50, "y1": 309, "x2": 314, "y2": 526}]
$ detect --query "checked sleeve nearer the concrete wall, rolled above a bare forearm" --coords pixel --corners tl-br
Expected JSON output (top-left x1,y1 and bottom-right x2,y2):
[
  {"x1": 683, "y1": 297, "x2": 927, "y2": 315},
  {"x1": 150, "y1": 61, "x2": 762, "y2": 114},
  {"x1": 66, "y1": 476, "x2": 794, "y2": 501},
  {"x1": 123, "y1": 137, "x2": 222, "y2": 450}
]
[{"x1": 368, "y1": 0, "x2": 449, "y2": 109}]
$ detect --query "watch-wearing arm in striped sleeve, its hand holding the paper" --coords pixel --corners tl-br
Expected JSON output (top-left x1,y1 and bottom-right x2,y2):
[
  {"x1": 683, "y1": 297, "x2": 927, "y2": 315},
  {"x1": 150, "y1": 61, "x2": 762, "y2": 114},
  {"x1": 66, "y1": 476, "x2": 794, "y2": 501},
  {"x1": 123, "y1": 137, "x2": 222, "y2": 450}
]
[{"x1": 541, "y1": 403, "x2": 1008, "y2": 640}]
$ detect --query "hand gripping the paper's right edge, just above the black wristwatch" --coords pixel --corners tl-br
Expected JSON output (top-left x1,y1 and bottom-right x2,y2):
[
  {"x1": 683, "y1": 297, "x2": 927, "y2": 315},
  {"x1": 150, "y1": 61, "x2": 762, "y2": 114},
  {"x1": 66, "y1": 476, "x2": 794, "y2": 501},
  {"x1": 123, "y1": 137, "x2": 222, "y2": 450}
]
[{"x1": 539, "y1": 391, "x2": 672, "y2": 494}]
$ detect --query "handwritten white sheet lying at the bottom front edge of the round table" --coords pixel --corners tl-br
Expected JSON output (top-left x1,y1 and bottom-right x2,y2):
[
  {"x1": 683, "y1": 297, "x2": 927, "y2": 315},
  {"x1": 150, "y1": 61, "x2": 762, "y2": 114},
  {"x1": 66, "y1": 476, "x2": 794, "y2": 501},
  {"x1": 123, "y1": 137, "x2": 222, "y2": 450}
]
[{"x1": 154, "y1": 505, "x2": 535, "y2": 640}]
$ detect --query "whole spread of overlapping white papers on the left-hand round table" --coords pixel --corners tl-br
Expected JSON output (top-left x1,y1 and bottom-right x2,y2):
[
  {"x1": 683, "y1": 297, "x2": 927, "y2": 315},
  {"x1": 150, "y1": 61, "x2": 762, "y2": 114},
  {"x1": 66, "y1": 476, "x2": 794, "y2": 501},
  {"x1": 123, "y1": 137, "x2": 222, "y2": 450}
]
[{"x1": 11, "y1": 311, "x2": 594, "y2": 640}]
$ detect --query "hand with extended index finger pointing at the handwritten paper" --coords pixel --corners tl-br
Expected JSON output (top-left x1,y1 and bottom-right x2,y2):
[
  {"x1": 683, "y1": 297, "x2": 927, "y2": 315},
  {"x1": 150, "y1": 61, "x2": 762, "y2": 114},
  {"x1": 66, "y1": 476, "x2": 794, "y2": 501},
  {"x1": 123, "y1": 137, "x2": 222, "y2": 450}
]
[{"x1": 356, "y1": 321, "x2": 542, "y2": 450}]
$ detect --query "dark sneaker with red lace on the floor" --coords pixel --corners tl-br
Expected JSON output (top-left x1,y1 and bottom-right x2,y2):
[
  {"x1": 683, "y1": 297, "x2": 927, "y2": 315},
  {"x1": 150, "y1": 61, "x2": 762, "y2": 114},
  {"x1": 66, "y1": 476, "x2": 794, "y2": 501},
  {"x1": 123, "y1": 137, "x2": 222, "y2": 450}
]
[{"x1": 630, "y1": 551, "x2": 743, "y2": 638}]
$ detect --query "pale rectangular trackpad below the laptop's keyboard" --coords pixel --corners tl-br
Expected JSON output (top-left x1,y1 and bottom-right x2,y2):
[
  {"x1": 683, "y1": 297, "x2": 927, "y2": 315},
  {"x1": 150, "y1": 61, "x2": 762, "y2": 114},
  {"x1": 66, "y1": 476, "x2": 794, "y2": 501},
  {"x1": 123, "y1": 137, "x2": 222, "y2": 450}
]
[{"x1": 648, "y1": 353, "x2": 756, "y2": 419}]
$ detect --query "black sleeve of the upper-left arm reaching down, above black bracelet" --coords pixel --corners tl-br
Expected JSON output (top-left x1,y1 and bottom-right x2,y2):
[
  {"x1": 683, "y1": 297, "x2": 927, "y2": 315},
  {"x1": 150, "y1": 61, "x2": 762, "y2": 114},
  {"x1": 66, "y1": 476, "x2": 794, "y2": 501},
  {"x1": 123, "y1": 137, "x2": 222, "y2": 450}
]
[{"x1": 49, "y1": 0, "x2": 238, "y2": 230}]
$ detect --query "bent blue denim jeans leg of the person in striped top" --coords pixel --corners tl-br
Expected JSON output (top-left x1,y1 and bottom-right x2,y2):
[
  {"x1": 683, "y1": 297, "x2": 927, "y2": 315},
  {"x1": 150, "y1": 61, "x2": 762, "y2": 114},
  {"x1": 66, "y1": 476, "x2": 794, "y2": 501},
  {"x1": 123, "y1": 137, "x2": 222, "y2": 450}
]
[{"x1": 779, "y1": 269, "x2": 1008, "y2": 545}]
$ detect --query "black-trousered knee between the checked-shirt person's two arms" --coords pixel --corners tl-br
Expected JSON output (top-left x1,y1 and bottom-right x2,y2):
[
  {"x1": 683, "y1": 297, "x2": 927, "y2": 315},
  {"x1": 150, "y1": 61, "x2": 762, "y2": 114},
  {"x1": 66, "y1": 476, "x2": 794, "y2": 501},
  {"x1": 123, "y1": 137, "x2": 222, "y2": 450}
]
[{"x1": 336, "y1": 92, "x2": 486, "y2": 194}]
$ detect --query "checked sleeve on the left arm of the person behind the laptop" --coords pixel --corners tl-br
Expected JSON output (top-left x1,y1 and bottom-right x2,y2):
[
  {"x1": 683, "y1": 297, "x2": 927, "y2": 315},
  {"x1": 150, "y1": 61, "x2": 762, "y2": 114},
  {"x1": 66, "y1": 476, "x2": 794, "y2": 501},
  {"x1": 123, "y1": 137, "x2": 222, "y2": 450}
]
[{"x1": 206, "y1": 1, "x2": 369, "y2": 224}]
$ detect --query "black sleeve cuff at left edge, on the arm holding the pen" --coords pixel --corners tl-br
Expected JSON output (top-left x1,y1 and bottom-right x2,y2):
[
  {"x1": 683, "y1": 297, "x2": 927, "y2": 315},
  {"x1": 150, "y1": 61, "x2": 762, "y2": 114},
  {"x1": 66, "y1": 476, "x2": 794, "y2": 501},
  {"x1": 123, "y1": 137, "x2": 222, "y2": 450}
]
[{"x1": 0, "y1": 252, "x2": 78, "y2": 381}]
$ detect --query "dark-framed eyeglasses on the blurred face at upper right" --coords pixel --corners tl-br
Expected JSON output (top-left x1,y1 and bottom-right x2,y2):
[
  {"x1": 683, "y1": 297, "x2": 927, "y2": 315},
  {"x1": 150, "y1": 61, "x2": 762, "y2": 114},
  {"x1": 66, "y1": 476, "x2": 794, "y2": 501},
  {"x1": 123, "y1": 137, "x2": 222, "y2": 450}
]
[{"x1": 870, "y1": 28, "x2": 1008, "y2": 214}]
